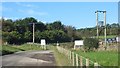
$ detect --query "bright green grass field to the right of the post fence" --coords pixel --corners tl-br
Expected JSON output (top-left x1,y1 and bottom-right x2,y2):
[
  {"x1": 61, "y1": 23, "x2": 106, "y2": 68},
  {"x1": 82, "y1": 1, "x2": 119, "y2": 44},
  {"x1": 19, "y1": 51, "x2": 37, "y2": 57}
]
[{"x1": 60, "y1": 43, "x2": 118, "y2": 66}]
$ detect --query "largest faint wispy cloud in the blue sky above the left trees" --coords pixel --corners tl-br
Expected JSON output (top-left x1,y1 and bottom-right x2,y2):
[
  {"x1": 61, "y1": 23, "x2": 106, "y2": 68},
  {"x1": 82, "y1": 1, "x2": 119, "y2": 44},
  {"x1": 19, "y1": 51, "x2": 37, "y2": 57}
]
[{"x1": 19, "y1": 9, "x2": 48, "y2": 16}]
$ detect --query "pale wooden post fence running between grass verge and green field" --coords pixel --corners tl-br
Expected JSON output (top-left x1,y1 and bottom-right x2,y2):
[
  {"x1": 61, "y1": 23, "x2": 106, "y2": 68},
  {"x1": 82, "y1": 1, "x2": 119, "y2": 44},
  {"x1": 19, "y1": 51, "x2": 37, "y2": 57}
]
[{"x1": 57, "y1": 46, "x2": 100, "y2": 68}]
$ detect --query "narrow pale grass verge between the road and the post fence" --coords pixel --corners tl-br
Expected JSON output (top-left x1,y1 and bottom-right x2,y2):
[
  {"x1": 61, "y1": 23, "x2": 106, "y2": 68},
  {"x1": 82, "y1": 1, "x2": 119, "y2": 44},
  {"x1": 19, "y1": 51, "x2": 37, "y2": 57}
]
[{"x1": 50, "y1": 46, "x2": 71, "y2": 66}]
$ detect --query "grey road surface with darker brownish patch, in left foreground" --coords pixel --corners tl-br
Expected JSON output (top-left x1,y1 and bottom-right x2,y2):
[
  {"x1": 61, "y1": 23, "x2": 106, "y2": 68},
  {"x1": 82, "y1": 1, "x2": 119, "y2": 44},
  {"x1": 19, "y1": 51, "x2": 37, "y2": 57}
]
[{"x1": 2, "y1": 50, "x2": 56, "y2": 66}]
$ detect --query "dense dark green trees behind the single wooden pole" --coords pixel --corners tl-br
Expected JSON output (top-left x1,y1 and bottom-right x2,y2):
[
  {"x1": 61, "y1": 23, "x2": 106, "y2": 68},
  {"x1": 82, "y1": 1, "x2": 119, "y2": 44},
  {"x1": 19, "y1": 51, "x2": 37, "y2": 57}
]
[{"x1": 0, "y1": 17, "x2": 82, "y2": 44}]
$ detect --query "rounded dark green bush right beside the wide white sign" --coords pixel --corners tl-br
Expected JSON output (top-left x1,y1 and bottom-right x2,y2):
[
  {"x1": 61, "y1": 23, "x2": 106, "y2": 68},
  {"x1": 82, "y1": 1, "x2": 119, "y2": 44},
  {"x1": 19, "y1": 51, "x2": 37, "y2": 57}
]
[{"x1": 84, "y1": 38, "x2": 99, "y2": 51}]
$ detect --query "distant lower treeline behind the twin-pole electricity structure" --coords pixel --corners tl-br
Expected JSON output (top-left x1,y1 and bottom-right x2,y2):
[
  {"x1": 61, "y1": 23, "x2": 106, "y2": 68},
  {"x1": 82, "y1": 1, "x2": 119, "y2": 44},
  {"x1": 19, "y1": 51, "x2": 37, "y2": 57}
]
[{"x1": 77, "y1": 23, "x2": 120, "y2": 37}]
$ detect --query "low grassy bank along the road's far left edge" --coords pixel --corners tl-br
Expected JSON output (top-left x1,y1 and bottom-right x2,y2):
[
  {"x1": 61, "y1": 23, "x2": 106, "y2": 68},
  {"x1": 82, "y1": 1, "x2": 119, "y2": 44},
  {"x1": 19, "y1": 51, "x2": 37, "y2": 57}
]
[{"x1": 0, "y1": 44, "x2": 42, "y2": 55}]
